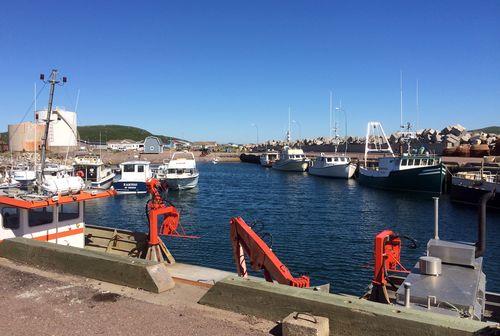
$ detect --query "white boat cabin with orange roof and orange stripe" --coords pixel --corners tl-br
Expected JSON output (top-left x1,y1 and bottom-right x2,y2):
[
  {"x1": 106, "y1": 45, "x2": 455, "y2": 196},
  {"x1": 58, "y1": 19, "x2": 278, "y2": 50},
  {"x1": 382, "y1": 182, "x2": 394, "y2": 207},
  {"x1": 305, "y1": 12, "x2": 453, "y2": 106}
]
[{"x1": 0, "y1": 190, "x2": 116, "y2": 248}]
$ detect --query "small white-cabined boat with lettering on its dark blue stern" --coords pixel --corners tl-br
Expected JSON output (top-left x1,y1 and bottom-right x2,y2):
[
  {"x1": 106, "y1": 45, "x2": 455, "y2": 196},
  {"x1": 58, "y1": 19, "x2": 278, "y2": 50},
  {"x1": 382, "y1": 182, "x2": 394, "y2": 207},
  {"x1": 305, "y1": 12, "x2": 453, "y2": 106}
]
[{"x1": 113, "y1": 161, "x2": 152, "y2": 194}]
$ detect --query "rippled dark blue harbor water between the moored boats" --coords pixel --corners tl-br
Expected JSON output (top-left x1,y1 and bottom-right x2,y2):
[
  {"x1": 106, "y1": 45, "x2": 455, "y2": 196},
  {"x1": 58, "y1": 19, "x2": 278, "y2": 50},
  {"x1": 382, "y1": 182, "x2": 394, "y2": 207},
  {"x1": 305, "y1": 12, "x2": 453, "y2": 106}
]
[{"x1": 85, "y1": 163, "x2": 500, "y2": 295}]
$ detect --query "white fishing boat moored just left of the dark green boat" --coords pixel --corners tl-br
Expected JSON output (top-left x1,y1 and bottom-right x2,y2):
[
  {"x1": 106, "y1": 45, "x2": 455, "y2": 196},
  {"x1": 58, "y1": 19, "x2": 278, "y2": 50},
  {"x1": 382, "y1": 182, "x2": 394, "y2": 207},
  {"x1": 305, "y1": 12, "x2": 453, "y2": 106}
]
[{"x1": 308, "y1": 153, "x2": 356, "y2": 179}]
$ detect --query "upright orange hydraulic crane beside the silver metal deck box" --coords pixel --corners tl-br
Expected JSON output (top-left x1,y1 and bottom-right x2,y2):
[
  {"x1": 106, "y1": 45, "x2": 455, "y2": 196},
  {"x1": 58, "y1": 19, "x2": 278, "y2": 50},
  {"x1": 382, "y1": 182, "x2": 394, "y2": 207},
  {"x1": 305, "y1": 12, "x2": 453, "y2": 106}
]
[{"x1": 370, "y1": 230, "x2": 415, "y2": 303}]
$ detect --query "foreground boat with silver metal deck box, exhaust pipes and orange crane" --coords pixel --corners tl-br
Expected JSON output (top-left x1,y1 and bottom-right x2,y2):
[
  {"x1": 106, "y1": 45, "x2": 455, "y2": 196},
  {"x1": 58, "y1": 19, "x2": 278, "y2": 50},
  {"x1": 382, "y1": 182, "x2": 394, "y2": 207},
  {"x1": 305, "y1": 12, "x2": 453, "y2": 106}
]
[{"x1": 364, "y1": 196, "x2": 500, "y2": 322}]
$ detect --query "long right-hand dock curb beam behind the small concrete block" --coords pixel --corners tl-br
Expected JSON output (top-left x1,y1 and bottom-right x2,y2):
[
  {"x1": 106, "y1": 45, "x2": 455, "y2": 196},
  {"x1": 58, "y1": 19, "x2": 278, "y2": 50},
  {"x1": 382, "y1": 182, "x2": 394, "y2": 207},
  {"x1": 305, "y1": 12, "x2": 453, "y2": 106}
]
[{"x1": 199, "y1": 277, "x2": 491, "y2": 336}]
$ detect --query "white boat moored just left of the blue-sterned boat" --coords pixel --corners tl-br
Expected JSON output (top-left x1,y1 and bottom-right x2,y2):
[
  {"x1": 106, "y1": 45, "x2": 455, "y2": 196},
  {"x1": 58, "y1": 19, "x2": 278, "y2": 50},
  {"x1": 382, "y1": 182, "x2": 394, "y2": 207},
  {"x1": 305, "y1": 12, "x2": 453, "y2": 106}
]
[{"x1": 73, "y1": 155, "x2": 116, "y2": 189}]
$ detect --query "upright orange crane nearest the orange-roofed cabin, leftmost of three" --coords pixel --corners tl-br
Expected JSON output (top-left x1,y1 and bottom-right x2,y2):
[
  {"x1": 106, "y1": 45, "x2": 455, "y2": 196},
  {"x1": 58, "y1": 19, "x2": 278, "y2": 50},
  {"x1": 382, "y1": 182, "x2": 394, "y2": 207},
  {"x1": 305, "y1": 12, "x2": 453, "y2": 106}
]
[{"x1": 146, "y1": 178, "x2": 199, "y2": 263}]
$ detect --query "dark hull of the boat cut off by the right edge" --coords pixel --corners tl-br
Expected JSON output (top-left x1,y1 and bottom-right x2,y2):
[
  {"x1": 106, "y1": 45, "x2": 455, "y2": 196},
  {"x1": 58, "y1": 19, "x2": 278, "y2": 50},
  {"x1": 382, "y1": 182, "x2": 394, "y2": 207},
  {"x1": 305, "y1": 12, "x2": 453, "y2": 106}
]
[{"x1": 450, "y1": 177, "x2": 500, "y2": 210}]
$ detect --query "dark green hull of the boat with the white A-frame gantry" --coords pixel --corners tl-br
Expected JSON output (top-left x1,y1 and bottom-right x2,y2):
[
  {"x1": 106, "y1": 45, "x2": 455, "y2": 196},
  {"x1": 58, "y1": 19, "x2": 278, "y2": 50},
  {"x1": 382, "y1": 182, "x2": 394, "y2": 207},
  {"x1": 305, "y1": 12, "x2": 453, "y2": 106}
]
[{"x1": 359, "y1": 165, "x2": 446, "y2": 194}]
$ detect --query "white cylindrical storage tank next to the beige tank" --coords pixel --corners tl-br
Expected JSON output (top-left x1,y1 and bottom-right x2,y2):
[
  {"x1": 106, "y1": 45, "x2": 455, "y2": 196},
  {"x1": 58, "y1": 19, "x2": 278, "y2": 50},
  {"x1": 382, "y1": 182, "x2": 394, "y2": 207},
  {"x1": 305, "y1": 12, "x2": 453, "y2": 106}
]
[{"x1": 35, "y1": 107, "x2": 77, "y2": 148}]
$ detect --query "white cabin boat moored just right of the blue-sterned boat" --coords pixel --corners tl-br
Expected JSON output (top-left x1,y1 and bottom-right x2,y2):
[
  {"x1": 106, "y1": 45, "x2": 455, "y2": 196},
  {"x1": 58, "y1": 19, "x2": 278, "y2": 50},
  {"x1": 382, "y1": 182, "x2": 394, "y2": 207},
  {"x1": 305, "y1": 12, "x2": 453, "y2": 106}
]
[{"x1": 156, "y1": 152, "x2": 200, "y2": 190}]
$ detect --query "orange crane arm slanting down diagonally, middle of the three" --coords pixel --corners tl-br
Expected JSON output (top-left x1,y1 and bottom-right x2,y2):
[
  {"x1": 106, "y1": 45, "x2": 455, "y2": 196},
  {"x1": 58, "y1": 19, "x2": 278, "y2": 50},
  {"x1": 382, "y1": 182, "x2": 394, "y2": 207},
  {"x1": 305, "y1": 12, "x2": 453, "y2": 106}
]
[{"x1": 230, "y1": 217, "x2": 310, "y2": 288}]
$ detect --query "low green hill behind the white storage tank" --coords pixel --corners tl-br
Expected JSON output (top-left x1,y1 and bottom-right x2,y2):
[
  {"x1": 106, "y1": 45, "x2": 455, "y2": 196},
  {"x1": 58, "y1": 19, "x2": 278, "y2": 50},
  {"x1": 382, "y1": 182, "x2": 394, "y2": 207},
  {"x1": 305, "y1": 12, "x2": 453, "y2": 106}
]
[{"x1": 78, "y1": 125, "x2": 178, "y2": 142}]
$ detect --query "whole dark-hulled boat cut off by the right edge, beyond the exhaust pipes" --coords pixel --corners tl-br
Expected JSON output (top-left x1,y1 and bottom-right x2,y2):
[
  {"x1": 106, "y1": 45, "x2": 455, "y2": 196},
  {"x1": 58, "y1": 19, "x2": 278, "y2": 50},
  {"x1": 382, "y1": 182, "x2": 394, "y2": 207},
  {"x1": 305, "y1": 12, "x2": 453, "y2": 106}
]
[{"x1": 450, "y1": 169, "x2": 500, "y2": 209}]
